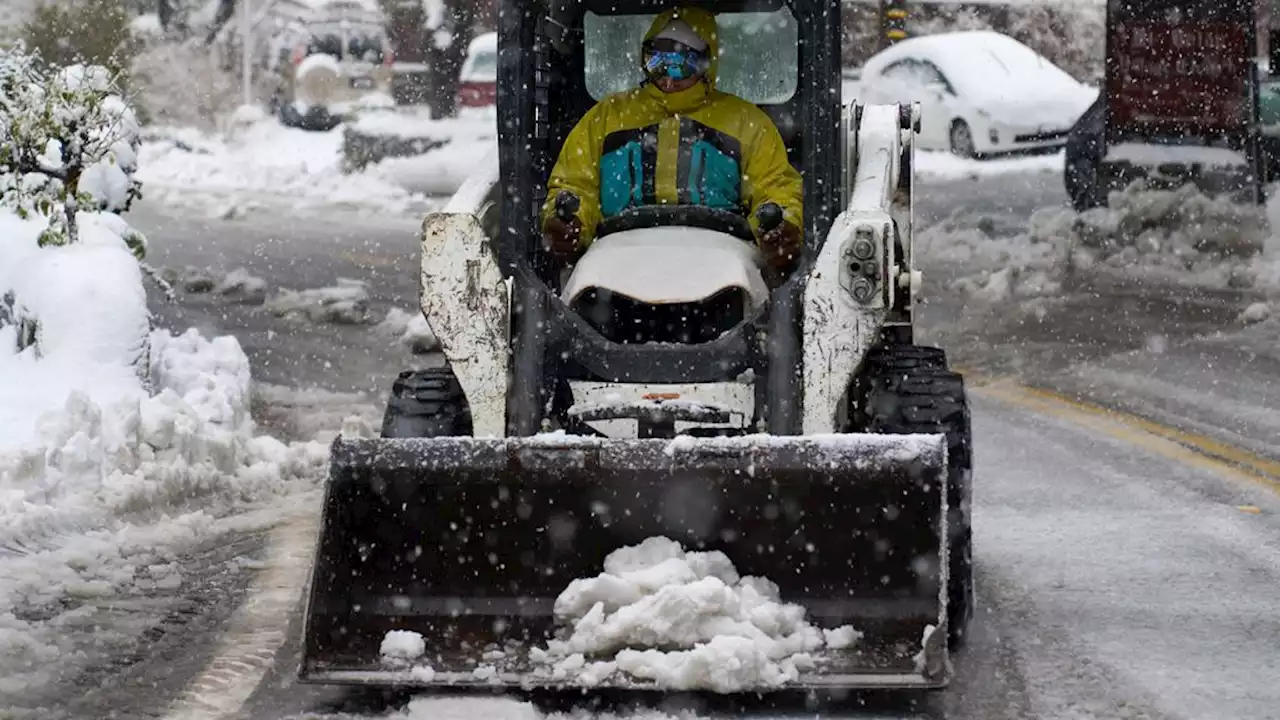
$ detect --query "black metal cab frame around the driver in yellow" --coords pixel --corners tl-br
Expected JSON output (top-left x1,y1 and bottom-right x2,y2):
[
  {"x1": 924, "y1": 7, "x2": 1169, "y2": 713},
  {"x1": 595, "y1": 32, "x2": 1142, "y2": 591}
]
[{"x1": 495, "y1": 0, "x2": 844, "y2": 436}]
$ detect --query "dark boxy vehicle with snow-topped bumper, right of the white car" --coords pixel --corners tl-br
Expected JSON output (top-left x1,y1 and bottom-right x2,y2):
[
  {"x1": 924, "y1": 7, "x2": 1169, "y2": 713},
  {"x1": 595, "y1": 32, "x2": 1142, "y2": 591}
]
[{"x1": 1064, "y1": 0, "x2": 1280, "y2": 209}]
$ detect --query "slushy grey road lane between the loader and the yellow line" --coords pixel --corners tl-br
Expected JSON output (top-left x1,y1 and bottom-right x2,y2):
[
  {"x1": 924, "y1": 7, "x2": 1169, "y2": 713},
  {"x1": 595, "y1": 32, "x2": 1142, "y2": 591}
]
[{"x1": 189, "y1": 382, "x2": 1280, "y2": 720}]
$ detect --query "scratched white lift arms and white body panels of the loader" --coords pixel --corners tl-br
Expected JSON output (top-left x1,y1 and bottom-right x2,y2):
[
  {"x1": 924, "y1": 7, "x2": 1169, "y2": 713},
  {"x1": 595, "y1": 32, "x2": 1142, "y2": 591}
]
[{"x1": 421, "y1": 105, "x2": 920, "y2": 437}]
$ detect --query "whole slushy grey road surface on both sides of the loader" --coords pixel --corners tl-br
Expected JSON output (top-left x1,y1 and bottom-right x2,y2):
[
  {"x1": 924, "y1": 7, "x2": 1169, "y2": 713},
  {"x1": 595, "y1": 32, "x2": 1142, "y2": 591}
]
[{"x1": 22, "y1": 158, "x2": 1249, "y2": 720}]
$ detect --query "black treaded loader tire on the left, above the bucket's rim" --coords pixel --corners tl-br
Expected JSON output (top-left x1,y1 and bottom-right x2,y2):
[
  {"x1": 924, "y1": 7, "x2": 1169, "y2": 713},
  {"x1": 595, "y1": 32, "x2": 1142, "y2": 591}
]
[{"x1": 381, "y1": 368, "x2": 471, "y2": 438}]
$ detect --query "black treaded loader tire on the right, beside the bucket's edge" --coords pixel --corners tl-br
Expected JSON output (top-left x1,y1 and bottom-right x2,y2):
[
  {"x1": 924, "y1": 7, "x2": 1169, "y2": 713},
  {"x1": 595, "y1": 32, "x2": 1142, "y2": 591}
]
[{"x1": 859, "y1": 345, "x2": 974, "y2": 650}]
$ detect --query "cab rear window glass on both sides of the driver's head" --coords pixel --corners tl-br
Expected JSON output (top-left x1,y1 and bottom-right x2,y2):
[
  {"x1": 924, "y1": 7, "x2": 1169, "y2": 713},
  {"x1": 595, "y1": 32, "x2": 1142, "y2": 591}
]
[{"x1": 584, "y1": 8, "x2": 797, "y2": 105}]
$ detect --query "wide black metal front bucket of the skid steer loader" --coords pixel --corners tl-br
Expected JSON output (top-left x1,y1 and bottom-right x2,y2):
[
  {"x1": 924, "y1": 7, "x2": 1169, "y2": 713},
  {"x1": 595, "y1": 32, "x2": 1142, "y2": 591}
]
[{"x1": 300, "y1": 434, "x2": 947, "y2": 689}]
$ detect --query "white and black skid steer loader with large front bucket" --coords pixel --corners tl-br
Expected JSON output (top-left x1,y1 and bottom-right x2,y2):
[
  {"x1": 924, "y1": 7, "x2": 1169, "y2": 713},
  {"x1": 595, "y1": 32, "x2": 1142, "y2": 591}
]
[{"x1": 300, "y1": 0, "x2": 973, "y2": 689}]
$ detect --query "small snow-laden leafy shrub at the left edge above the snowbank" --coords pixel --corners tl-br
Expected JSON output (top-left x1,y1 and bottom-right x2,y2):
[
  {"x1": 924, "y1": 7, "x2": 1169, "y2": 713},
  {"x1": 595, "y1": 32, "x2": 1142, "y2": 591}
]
[{"x1": 0, "y1": 47, "x2": 146, "y2": 243}]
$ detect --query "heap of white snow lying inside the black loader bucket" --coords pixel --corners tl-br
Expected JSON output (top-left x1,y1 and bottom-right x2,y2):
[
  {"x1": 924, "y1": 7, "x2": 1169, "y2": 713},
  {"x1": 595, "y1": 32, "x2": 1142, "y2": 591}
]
[{"x1": 381, "y1": 537, "x2": 861, "y2": 693}]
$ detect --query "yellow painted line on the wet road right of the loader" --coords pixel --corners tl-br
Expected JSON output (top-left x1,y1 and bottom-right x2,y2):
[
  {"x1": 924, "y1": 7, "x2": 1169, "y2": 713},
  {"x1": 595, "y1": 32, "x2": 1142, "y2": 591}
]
[{"x1": 957, "y1": 370, "x2": 1280, "y2": 497}]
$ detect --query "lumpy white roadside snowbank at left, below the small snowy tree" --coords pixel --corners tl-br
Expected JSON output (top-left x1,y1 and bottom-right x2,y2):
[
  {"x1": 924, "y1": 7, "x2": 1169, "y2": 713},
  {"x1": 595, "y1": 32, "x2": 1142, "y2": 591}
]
[{"x1": 0, "y1": 202, "x2": 328, "y2": 717}]
